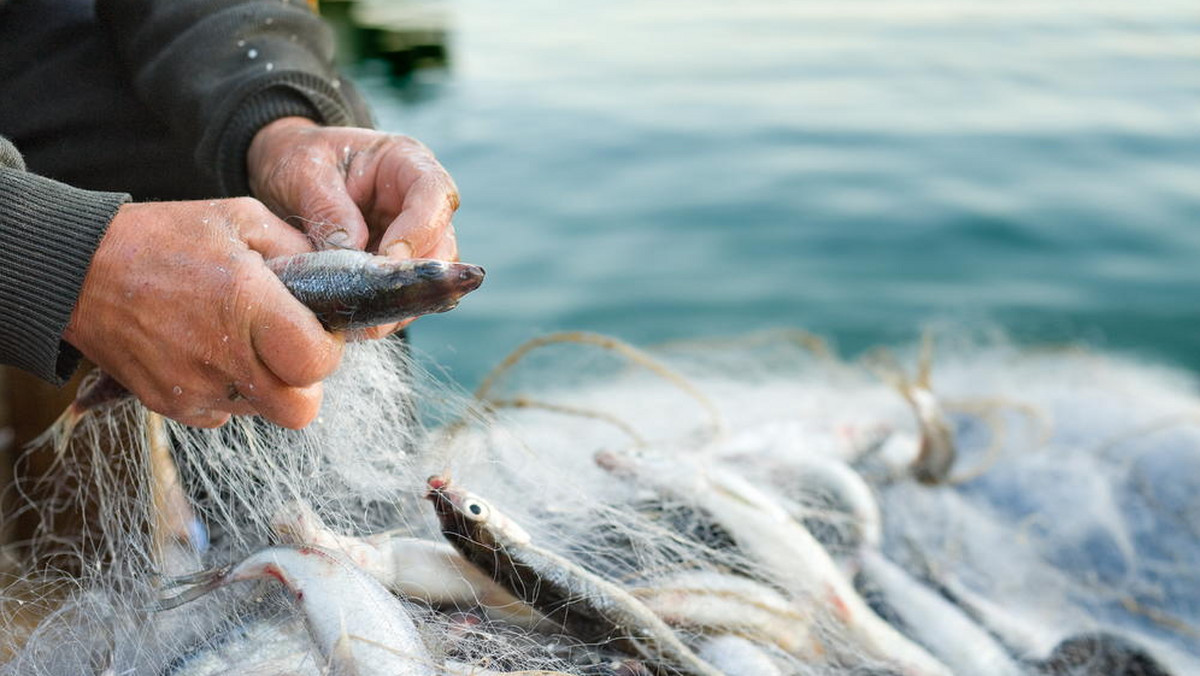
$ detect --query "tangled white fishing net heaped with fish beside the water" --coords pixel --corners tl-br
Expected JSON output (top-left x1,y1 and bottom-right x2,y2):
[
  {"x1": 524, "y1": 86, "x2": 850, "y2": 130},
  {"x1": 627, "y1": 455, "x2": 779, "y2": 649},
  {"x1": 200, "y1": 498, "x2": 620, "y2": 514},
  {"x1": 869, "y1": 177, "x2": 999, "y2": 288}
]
[{"x1": 0, "y1": 331, "x2": 1200, "y2": 676}]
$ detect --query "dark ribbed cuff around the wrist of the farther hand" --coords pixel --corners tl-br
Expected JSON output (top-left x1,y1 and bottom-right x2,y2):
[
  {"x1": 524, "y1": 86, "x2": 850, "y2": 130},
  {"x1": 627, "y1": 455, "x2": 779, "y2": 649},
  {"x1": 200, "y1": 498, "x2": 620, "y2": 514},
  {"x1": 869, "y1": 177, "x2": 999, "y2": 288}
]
[{"x1": 204, "y1": 71, "x2": 371, "y2": 196}]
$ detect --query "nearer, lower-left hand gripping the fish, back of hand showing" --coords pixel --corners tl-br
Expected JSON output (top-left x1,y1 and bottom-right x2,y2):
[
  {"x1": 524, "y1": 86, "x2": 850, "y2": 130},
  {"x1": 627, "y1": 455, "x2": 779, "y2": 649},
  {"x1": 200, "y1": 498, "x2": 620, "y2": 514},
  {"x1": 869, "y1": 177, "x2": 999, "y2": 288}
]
[{"x1": 64, "y1": 197, "x2": 342, "y2": 427}]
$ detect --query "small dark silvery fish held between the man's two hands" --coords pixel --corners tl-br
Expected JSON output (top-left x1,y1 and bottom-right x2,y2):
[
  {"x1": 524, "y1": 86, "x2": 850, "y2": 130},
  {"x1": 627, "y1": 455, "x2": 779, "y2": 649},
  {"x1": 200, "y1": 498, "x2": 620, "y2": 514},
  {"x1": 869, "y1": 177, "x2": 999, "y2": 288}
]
[{"x1": 266, "y1": 250, "x2": 484, "y2": 330}]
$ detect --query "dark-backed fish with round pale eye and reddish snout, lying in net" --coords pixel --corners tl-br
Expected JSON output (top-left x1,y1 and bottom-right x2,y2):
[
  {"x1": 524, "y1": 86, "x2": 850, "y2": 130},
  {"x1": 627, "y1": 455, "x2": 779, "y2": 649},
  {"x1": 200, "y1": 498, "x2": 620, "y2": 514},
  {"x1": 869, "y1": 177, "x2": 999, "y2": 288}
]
[{"x1": 428, "y1": 477, "x2": 722, "y2": 676}]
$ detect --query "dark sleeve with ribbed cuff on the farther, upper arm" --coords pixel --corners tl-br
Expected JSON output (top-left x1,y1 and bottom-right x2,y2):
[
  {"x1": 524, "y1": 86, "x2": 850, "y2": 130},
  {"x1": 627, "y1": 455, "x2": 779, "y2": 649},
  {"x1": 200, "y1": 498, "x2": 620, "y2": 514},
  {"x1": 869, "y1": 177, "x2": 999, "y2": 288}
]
[{"x1": 97, "y1": 0, "x2": 371, "y2": 196}]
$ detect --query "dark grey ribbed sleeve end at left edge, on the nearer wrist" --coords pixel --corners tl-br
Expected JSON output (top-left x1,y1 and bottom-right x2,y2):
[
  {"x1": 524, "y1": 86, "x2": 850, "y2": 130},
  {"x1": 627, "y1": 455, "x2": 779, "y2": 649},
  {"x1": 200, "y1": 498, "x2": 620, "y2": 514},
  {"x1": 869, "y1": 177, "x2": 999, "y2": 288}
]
[{"x1": 0, "y1": 137, "x2": 130, "y2": 384}]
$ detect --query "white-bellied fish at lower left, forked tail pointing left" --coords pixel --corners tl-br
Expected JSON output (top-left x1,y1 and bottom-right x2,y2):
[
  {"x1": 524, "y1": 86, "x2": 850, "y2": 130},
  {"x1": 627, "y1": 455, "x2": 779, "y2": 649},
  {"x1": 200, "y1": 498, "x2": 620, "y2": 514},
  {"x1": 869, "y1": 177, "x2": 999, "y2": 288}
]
[{"x1": 158, "y1": 545, "x2": 437, "y2": 676}]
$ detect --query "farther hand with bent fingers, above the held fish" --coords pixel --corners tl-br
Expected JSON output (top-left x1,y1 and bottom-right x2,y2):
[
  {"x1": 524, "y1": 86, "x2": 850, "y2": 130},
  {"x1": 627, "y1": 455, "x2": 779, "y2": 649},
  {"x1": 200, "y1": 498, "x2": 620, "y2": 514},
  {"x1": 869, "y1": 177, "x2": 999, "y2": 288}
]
[{"x1": 246, "y1": 118, "x2": 458, "y2": 337}]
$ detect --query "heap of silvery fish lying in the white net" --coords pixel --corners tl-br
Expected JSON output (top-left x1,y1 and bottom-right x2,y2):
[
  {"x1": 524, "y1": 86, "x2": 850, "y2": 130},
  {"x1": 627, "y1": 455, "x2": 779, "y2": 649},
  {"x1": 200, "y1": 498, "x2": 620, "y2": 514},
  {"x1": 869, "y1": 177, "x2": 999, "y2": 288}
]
[{"x1": 145, "y1": 333, "x2": 1187, "y2": 676}]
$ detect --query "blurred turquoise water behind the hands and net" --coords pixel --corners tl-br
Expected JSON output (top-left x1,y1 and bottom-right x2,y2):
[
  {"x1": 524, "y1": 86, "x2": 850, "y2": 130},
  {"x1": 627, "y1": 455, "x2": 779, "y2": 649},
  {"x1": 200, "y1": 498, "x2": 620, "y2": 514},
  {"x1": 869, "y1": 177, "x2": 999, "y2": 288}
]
[{"x1": 354, "y1": 0, "x2": 1200, "y2": 384}]
